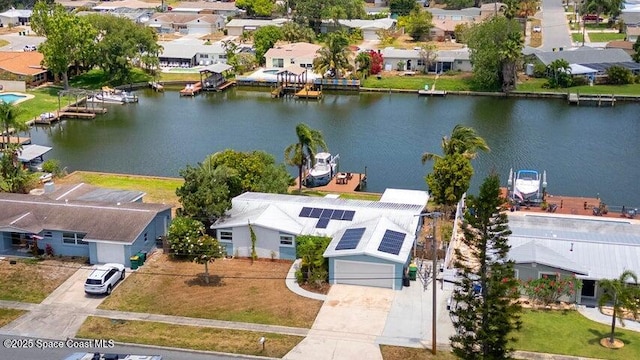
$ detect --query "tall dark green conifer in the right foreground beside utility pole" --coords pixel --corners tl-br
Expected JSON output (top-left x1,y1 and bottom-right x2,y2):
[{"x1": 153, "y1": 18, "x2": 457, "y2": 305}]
[{"x1": 451, "y1": 174, "x2": 521, "y2": 360}]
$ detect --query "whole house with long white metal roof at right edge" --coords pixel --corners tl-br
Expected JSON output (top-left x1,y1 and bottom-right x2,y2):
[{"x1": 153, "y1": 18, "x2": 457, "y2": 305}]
[{"x1": 509, "y1": 212, "x2": 640, "y2": 304}]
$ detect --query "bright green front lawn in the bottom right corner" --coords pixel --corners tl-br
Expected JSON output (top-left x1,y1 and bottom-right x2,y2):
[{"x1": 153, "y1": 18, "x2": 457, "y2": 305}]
[{"x1": 515, "y1": 310, "x2": 640, "y2": 359}]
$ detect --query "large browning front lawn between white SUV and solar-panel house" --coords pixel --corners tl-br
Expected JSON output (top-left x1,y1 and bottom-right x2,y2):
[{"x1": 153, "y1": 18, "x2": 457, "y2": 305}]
[{"x1": 100, "y1": 254, "x2": 322, "y2": 328}]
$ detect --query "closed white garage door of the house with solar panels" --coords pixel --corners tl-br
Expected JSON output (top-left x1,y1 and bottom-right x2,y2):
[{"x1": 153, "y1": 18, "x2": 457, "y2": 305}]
[{"x1": 333, "y1": 260, "x2": 395, "y2": 289}]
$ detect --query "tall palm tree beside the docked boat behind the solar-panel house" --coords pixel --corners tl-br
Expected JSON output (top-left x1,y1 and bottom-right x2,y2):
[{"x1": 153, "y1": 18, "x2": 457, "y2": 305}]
[{"x1": 284, "y1": 123, "x2": 328, "y2": 190}]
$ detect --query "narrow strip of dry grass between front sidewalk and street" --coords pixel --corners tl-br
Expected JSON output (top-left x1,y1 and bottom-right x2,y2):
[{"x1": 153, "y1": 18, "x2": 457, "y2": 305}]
[{"x1": 77, "y1": 317, "x2": 303, "y2": 358}]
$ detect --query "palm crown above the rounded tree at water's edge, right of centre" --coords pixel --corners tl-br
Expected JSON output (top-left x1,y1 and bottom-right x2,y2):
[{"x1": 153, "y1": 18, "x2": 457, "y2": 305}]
[{"x1": 422, "y1": 124, "x2": 491, "y2": 164}]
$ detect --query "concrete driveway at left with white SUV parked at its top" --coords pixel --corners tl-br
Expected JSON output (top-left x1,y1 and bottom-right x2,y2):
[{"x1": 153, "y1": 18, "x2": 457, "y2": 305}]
[{"x1": 2, "y1": 268, "x2": 124, "y2": 340}]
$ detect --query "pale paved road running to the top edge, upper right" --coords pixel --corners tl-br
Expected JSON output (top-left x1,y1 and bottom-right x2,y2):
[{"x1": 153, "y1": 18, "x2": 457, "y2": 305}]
[{"x1": 540, "y1": 0, "x2": 573, "y2": 51}]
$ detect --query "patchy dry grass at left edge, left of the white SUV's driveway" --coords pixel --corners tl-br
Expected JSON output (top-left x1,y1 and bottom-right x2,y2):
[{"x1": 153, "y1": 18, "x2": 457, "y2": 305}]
[{"x1": 0, "y1": 259, "x2": 82, "y2": 303}]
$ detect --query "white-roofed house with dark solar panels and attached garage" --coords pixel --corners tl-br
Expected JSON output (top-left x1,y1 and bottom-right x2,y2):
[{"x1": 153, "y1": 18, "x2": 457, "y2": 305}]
[{"x1": 211, "y1": 189, "x2": 429, "y2": 289}]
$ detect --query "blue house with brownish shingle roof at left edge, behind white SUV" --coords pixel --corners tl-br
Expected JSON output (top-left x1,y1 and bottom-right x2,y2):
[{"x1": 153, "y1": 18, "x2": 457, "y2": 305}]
[{"x1": 0, "y1": 193, "x2": 171, "y2": 266}]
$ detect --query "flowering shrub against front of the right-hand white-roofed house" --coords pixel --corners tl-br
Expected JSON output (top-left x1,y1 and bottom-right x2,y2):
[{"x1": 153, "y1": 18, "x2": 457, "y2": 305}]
[{"x1": 522, "y1": 273, "x2": 582, "y2": 306}]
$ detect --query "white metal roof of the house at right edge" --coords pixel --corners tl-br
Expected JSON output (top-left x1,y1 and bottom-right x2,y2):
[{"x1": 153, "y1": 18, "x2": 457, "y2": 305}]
[{"x1": 509, "y1": 213, "x2": 640, "y2": 280}]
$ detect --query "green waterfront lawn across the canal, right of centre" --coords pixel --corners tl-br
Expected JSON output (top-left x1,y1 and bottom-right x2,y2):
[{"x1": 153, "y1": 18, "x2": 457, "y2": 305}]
[{"x1": 361, "y1": 75, "x2": 472, "y2": 91}]
